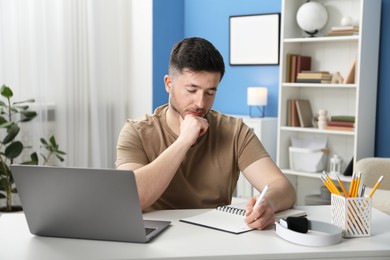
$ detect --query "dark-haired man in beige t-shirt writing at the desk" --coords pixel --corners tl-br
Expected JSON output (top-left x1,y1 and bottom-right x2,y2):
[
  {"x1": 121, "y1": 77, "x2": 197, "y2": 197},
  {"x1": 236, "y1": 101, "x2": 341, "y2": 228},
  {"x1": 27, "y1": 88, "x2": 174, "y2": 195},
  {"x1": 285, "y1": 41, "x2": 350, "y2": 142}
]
[{"x1": 116, "y1": 37, "x2": 295, "y2": 229}]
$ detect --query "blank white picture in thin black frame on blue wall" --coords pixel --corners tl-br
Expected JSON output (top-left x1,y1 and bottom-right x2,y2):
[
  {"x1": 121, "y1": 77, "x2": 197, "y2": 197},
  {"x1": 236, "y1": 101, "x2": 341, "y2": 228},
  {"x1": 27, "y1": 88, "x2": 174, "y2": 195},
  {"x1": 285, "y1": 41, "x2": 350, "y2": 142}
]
[{"x1": 229, "y1": 13, "x2": 280, "y2": 65}]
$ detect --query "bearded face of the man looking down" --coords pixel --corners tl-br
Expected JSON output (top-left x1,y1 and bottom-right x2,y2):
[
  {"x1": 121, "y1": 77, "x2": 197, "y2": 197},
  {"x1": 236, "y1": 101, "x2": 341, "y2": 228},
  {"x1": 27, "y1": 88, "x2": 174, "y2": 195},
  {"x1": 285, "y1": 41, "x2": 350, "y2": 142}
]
[{"x1": 164, "y1": 70, "x2": 221, "y2": 118}]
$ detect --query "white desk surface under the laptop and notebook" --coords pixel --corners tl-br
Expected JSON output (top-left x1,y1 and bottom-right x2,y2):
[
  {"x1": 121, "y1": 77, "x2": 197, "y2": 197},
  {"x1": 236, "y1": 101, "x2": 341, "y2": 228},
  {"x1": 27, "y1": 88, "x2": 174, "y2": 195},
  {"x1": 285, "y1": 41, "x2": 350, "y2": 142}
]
[{"x1": 0, "y1": 206, "x2": 390, "y2": 260}]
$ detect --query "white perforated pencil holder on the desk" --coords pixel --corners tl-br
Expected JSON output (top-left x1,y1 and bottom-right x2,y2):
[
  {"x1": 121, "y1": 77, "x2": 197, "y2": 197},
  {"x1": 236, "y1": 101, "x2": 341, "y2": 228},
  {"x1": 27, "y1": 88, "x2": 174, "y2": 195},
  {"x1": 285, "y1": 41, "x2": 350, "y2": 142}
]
[{"x1": 331, "y1": 194, "x2": 371, "y2": 238}]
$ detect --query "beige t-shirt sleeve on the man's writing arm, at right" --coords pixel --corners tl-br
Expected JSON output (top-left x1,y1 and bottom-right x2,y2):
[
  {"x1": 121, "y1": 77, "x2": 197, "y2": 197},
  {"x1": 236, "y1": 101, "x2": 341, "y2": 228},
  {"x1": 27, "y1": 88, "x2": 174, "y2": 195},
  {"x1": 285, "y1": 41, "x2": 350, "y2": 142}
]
[{"x1": 238, "y1": 123, "x2": 269, "y2": 171}]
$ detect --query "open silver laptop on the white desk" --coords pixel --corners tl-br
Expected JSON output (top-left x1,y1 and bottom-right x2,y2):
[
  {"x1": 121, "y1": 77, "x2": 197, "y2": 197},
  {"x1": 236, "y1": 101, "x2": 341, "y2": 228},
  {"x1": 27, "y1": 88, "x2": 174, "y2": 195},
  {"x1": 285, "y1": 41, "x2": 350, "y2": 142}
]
[{"x1": 11, "y1": 165, "x2": 170, "y2": 243}]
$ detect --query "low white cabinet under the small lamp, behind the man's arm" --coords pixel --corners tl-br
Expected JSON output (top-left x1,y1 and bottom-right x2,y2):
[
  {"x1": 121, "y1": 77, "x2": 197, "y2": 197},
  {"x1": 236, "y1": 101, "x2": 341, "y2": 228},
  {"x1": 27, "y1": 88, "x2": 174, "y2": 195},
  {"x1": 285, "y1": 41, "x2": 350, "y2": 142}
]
[{"x1": 233, "y1": 115, "x2": 277, "y2": 199}]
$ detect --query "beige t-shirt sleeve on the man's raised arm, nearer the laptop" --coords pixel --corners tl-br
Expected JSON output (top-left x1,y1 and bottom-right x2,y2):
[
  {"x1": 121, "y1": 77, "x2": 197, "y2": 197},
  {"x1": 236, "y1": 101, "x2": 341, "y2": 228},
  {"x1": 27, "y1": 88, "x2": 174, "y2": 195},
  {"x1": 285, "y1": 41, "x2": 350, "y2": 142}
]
[{"x1": 115, "y1": 120, "x2": 149, "y2": 167}]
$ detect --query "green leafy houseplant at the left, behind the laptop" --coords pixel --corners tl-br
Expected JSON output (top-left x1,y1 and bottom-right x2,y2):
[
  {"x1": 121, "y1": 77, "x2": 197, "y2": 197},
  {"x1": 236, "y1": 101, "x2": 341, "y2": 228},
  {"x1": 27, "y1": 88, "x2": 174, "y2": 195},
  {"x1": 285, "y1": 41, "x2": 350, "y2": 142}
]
[{"x1": 0, "y1": 85, "x2": 65, "y2": 212}]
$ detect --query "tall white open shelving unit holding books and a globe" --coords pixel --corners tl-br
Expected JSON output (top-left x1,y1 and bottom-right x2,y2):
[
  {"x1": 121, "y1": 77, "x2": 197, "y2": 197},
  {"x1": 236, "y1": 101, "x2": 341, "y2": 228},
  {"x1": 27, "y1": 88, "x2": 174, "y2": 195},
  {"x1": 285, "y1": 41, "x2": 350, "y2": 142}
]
[{"x1": 277, "y1": 0, "x2": 381, "y2": 205}]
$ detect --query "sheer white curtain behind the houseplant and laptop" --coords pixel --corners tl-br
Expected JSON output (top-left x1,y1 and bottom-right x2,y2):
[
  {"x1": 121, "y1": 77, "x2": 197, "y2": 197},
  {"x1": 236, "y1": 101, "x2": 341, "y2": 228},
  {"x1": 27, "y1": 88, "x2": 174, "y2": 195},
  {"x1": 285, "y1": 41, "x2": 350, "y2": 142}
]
[{"x1": 0, "y1": 0, "x2": 152, "y2": 168}]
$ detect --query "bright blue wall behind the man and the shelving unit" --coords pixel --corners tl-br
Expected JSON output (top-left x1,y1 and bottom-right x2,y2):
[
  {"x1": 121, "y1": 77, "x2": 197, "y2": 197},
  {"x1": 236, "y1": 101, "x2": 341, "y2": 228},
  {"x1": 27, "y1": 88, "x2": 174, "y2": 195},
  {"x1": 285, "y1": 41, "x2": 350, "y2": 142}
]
[{"x1": 153, "y1": 0, "x2": 390, "y2": 157}]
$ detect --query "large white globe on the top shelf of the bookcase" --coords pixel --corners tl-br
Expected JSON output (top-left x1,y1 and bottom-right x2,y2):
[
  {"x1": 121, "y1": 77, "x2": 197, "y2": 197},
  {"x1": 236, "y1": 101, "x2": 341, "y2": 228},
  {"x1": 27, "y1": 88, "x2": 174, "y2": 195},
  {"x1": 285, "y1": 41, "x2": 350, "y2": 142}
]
[{"x1": 297, "y1": 2, "x2": 328, "y2": 35}]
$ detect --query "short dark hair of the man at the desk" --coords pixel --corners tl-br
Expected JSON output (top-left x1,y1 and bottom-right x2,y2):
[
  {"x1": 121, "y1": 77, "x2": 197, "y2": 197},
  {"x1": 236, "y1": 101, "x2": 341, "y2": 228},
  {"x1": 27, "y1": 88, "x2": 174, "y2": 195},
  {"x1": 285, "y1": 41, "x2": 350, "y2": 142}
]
[{"x1": 169, "y1": 37, "x2": 225, "y2": 80}]
